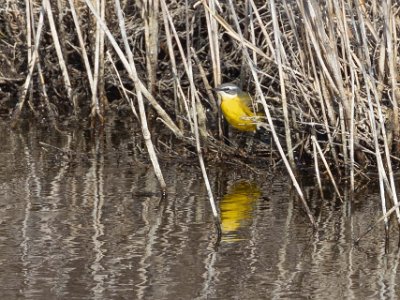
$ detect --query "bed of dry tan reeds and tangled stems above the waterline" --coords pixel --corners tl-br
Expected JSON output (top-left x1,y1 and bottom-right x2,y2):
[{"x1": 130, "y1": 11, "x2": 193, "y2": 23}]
[{"x1": 0, "y1": 0, "x2": 400, "y2": 226}]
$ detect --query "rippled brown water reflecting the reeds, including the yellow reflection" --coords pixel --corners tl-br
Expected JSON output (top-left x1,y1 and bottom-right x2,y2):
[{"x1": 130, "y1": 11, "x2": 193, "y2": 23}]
[{"x1": 0, "y1": 118, "x2": 400, "y2": 299}]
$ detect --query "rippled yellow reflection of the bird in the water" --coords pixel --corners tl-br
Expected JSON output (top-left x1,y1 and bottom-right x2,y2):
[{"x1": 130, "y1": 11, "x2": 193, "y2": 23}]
[{"x1": 219, "y1": 180, "x2": 261, "y2": 242}]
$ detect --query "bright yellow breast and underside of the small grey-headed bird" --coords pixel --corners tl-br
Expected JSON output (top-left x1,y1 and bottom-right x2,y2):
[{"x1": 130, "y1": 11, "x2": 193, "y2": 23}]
[{"x1": 221, "y1": 97, "x2": 257, "y2": 131}]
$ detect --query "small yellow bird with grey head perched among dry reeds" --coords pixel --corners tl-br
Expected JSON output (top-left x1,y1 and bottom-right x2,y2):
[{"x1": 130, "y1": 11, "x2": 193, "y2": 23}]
[{"x1": 214, "y1": 83, "x2": 257, "y2": 132}]
